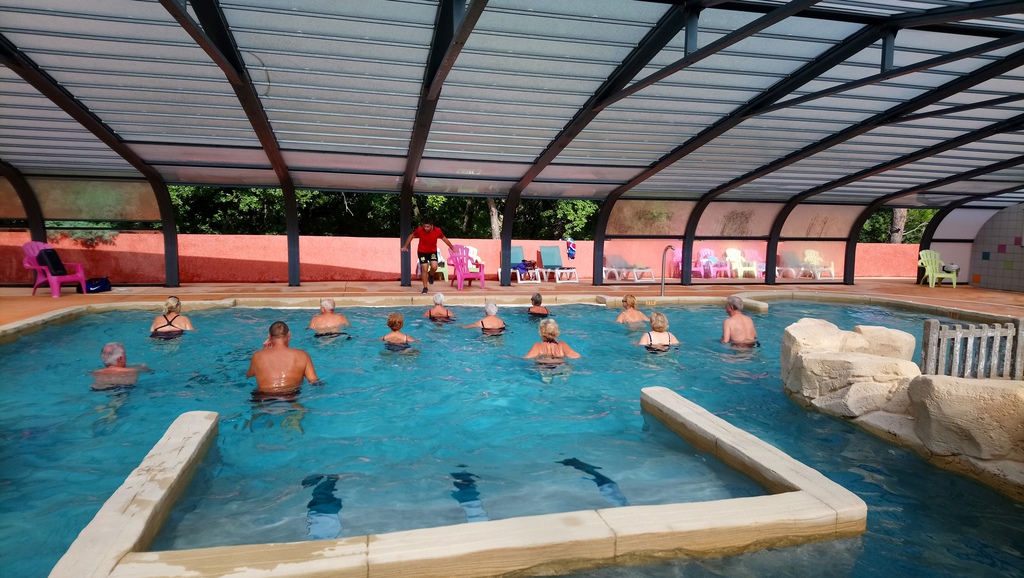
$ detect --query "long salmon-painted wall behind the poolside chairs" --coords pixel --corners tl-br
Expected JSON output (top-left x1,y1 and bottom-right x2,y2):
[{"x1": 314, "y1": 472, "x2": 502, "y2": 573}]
[{"x1": 0, "y1": 232, "x2": 918, "y2": 285}]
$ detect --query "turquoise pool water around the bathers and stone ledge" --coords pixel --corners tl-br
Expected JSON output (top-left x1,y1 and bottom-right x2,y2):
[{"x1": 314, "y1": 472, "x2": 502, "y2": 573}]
[{"x1": 0, "y1": 301, "x2": 1024, "y2": 577}]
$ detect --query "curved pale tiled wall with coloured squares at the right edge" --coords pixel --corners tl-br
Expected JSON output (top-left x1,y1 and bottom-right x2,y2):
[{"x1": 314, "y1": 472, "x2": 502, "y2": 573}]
[{"x1": 971, "y1": 204, "x2": 1024, "y2": 292}]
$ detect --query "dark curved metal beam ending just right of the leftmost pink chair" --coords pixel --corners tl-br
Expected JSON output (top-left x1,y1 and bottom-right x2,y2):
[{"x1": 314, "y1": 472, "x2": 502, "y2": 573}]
[{"x1": 0, "y1": 34, "x2": 179, "y2": 287}]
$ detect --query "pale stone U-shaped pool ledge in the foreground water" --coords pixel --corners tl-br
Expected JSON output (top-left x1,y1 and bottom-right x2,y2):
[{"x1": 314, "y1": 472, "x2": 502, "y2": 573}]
[{"x1": 50, "y1": 387, "x2": 867, "y2": 578}]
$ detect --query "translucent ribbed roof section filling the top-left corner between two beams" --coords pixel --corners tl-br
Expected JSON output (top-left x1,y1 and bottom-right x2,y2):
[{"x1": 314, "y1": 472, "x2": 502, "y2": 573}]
[{"x1": 0, "y1": 0, "x2": 258, "y2": 146}]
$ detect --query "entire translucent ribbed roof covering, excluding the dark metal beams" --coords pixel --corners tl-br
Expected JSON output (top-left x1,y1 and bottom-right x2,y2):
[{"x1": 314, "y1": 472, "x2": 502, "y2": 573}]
[{"x1": 0, "y1": 0, "x2": 1024, "y2": 219}]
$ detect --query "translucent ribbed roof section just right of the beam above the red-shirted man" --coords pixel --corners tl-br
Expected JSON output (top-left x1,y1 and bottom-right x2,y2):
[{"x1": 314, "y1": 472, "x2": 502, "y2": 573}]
[{"x1": 425, "y1": 0, "x2": 668, "y2": 162}]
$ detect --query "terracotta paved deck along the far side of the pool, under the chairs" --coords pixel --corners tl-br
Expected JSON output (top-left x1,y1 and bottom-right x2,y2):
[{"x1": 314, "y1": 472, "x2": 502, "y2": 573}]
[{"x1": 0, "y1": 279, "x2": 1024, "y2": 326}]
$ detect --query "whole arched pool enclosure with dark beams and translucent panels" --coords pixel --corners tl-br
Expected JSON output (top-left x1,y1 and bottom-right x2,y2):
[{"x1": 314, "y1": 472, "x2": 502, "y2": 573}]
[{"x1": 0, "y1": 0, "x2": 1024, "y2": 286}]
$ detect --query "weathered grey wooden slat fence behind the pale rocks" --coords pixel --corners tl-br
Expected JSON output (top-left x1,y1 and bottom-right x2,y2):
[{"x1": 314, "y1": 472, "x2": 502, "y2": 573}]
[{"x1": 921, "y1": 319, "x2": 1024, "y2": 380}]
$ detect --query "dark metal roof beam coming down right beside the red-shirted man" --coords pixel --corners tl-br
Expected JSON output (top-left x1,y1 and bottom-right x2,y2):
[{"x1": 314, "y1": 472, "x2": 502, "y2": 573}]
[{"x1": 398, "y1": 0, "x2": 487, "y2": 287}]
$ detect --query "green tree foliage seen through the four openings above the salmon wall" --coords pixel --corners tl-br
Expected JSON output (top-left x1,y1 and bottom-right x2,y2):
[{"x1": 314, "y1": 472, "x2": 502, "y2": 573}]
[{"x1": 168, "y1": 187, "x2": 600, "y2": 240}]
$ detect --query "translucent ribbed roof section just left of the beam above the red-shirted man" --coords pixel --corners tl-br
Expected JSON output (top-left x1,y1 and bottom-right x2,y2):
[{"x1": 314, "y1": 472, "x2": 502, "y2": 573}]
[{"x1": 221, "y1": 0, "x2": 437, "y2": 155}]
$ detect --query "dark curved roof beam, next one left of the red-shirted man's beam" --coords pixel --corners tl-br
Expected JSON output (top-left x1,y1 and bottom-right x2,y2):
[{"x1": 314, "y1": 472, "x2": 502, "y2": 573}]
[{"x1": 160, "y1": 0, "x2": 300, "y2": 287}]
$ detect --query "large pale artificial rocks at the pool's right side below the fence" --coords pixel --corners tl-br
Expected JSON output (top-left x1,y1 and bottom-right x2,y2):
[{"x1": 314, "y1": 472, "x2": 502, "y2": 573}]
[{"x1": 780, "y1": 319, "x2": 1024, "y2": 501}]
